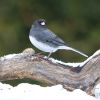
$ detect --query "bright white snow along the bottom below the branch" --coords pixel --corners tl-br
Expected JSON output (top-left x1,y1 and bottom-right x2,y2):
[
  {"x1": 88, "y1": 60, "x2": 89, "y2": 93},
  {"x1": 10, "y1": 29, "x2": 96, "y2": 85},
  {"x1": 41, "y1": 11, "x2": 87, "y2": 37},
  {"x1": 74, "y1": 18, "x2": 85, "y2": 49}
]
[{"x1": 0, "y1": 83, "x2": 97, "y2": 100}]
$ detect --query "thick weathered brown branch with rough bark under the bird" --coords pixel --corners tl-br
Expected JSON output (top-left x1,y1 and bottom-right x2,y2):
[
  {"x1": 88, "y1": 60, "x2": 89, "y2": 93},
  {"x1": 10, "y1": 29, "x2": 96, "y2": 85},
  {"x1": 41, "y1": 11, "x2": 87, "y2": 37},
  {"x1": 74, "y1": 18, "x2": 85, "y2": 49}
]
[{"x1": 0, "y1": 49, "x2": 100, "y2": 95}]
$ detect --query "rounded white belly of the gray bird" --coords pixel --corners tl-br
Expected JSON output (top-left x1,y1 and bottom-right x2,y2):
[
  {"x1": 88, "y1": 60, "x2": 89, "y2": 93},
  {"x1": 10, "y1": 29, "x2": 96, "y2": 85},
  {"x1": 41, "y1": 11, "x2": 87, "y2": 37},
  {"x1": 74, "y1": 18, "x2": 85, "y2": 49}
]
[{"x1": 29, "y1": 35, "x2": 56, "y2": 52}]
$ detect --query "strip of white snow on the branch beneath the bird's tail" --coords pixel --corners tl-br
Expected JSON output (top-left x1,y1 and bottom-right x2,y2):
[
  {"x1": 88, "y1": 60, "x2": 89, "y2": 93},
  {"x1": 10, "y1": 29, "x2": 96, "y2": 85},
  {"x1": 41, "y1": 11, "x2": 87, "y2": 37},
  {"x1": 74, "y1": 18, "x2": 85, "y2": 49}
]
[{"x1": 44, "y1": 50, "x2": 100, "y2": 67}]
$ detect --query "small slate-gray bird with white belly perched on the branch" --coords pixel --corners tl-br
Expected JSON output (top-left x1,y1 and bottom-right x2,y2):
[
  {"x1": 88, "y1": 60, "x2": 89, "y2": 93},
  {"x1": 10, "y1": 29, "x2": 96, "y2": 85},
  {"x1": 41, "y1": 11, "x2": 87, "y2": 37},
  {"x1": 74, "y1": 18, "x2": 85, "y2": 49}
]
[{"x1": 29, "y1": 18, "x2": 88, "y2": 58}]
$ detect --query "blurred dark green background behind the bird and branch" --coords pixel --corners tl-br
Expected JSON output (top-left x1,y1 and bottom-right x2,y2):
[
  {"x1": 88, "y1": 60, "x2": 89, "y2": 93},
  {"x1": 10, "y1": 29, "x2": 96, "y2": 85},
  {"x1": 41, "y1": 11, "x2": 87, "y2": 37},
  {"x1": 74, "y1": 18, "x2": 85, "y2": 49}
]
[{"x1": 0, "y1": 0, "x2": 100, "y2": 62}]
